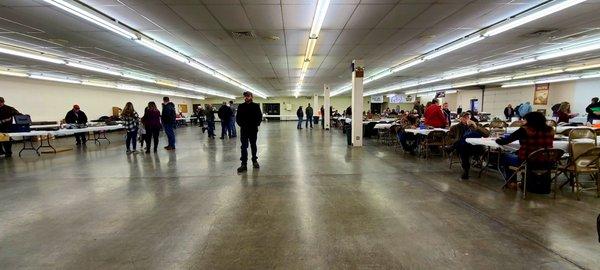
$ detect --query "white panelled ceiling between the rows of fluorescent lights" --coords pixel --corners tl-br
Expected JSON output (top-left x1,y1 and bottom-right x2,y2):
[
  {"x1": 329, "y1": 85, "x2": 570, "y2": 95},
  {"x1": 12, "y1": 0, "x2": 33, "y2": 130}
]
[{"x1": 0, "y1": 0, "x2": 600, "y2": 96}]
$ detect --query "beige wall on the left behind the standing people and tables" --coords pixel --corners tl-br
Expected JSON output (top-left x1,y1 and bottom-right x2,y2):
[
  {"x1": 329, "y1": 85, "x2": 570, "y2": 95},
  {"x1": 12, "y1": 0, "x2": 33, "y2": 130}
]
[{"x1": 0, "y1": 76, "x2": 192, "y2": 121}]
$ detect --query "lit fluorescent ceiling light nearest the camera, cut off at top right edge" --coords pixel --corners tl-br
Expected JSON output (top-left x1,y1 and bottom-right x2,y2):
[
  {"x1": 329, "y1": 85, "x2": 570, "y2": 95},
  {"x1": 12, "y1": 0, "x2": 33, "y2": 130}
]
[{"x1": 484, "y1": 0, "x2": 586, "y2": 37}]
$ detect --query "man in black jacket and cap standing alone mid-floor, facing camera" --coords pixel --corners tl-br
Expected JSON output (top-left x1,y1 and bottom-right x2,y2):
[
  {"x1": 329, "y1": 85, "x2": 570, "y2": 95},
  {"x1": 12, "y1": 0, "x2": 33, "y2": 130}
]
[{"x1": 236, "y1": 91, "x2": 262, "y2": 173}]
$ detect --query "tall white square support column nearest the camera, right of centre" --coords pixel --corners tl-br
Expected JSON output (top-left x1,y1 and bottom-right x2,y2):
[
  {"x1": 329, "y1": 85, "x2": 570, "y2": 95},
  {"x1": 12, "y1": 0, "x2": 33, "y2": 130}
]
[{"x1": 352, "y1": 60, "x2": 365, "y2": 147}]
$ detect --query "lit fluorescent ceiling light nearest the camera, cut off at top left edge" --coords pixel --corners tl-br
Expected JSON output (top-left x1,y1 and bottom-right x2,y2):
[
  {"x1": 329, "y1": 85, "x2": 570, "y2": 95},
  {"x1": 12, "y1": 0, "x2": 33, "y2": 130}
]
[{"x1": 44, "y1": 0, "x2": 137, "y2": 39}]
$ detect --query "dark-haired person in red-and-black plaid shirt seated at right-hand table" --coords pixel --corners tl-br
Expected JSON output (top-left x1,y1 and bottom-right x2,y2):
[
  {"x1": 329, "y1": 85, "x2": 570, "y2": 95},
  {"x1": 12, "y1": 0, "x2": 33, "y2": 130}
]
[{"x1": 496, "y1": 112, "x2": 554, "y2": 184}]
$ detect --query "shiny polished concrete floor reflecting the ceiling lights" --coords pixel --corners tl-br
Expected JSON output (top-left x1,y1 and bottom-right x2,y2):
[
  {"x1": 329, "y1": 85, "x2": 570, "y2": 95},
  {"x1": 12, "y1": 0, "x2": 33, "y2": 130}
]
[{"x1": 0, "y1": 122, "x2": 600, "y2": 269}]
